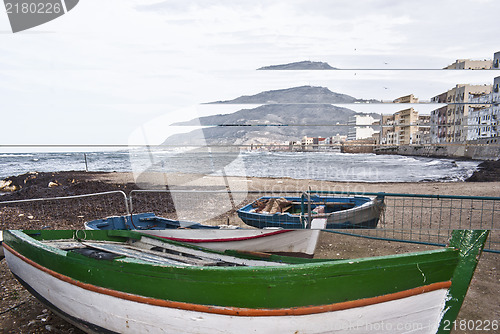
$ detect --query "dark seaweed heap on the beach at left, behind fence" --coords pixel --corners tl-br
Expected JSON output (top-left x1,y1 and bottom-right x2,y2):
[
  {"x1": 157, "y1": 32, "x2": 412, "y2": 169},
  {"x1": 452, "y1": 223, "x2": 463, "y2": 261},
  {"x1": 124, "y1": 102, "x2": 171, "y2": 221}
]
[{"x1": 0, "y1": 171, "x2": 174, "y2": 229}]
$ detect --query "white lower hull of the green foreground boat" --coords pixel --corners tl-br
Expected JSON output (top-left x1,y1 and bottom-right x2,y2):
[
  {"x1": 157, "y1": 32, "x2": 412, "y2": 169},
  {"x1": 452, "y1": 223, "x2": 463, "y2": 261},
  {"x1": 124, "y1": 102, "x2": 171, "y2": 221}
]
[{"x1": 5, "y1": 250, "x2": 448, "y2": 334}]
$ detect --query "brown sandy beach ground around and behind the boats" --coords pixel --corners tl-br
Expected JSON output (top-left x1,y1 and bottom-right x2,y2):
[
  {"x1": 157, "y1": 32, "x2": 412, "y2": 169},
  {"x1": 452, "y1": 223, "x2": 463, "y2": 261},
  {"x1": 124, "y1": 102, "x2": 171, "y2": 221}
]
[{"x1": 0, "y1": 172, "x2": 500, "y2": 333}]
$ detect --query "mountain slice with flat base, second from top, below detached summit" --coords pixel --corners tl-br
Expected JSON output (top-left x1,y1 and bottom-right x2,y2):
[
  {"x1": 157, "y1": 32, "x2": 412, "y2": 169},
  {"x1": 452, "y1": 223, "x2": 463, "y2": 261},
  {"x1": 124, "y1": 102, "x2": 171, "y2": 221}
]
[{"x1": 205, "y1": 86, "x2": 378, "y2": 104}]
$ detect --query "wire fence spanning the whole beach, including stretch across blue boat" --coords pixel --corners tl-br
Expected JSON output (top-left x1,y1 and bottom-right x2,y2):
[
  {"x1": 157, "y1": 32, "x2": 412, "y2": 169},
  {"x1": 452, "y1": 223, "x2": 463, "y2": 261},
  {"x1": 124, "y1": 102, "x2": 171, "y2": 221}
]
[{"x1": 0, "y1": 190, "x2": 500, "y2": 253}]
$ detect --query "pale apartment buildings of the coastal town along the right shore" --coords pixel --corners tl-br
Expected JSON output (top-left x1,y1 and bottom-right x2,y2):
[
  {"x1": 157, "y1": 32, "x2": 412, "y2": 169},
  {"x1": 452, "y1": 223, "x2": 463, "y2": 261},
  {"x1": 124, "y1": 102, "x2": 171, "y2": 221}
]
[{"x1": 258, "y1": 52, "x2": 500, "y2": 159}]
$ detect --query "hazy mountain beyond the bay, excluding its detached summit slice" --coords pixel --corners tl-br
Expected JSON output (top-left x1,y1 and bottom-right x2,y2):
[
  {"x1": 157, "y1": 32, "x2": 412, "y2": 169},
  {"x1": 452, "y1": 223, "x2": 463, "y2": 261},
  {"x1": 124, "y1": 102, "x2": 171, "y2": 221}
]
[{"x1": 164, "y1": 86, "x2": 379, "y2": 145}]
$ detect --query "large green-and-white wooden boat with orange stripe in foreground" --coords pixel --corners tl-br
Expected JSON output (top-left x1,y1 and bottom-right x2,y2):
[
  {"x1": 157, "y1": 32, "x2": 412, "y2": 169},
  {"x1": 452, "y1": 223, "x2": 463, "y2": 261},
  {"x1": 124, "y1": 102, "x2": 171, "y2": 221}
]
[{"x1": 3, "y1": 230, "x2": 488, "y2": 333}]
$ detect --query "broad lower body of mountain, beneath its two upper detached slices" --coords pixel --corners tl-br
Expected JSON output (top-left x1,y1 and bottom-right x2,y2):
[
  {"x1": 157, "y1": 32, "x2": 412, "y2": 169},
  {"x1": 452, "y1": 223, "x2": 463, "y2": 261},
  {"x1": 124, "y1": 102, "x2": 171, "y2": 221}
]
[{"x1": 164, "y1": 104, "x2": 378, "y2": 145}]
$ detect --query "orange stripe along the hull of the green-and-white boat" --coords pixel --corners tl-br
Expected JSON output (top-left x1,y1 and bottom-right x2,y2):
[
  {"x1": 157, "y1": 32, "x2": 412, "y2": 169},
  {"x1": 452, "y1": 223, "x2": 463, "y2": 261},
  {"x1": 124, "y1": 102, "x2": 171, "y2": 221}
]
[{"x1": 3, "y1": 244, "x2": 451, "y2": 317}]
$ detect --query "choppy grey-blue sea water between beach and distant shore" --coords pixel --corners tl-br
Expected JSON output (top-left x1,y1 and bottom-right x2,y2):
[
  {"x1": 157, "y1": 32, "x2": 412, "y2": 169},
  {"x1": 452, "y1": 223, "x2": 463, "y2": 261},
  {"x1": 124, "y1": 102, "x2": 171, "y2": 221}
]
[{"x1": 0, "y1": 149, "x2": 480, "y2": 182}]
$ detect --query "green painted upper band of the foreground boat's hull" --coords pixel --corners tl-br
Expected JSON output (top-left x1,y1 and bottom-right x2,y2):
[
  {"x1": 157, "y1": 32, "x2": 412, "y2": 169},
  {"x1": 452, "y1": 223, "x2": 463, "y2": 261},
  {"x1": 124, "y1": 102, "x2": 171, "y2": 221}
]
[{"x1": 0, "y1": 231, "x2": 480, "y2": 309}]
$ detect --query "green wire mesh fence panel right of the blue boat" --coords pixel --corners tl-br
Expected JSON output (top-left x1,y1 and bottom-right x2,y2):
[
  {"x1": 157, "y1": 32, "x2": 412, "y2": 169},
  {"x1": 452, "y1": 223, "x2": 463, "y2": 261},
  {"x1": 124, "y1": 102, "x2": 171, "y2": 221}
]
[{"x1": 311, "y1": 191, "x2": 500, "y2": 253}]
